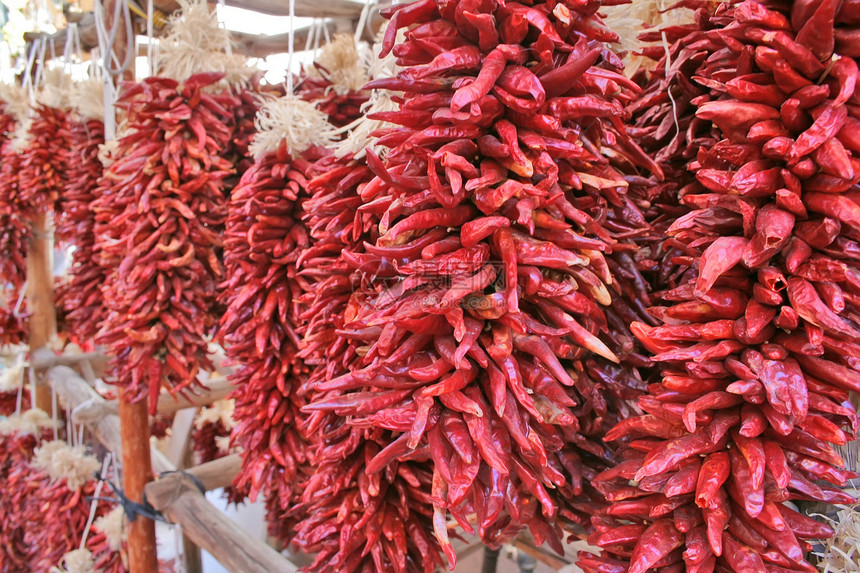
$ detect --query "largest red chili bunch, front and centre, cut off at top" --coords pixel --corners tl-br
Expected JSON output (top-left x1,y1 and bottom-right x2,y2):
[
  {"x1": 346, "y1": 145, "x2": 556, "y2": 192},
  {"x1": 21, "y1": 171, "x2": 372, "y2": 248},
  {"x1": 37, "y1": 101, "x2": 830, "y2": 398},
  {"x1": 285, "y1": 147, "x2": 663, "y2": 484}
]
[{"x1": 298, "y1": 1, "x2": 652, "y2": 563}]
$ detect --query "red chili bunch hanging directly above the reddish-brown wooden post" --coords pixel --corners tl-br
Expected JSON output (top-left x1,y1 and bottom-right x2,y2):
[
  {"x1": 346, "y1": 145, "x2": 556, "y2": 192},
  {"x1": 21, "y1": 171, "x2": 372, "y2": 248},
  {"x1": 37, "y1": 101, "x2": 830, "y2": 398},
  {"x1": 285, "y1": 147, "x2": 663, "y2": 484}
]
[{"x1": 97, "y1": 74, "x2": 238, "y2": 412}]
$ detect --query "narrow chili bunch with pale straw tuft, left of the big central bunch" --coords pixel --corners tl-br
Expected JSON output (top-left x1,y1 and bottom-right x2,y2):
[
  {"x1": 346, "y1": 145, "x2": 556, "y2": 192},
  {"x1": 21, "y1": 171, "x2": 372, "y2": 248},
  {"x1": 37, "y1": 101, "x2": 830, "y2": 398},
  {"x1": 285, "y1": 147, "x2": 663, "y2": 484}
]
[{"x1": 219, "y1": 97, "x2": 330, "y2": 512}]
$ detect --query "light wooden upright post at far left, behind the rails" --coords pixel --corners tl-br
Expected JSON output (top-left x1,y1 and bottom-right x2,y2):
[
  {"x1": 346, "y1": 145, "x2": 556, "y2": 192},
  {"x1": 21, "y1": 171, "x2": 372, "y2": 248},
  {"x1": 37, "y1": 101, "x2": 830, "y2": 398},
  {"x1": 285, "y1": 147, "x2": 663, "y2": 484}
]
[{"x1": 27, "y1": 213, "x2": 57, "y2": 414}]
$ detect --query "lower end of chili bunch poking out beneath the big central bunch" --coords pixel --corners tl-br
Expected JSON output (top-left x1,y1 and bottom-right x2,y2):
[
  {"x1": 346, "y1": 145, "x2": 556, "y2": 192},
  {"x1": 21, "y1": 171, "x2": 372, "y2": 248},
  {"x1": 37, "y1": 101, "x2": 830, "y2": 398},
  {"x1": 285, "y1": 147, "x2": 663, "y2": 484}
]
[{"x1": 290, "y1": 415, "x2": 445, "y2": 573}]
